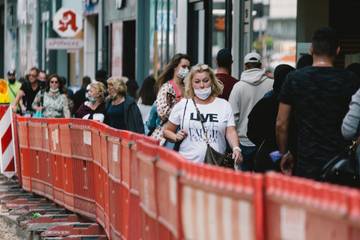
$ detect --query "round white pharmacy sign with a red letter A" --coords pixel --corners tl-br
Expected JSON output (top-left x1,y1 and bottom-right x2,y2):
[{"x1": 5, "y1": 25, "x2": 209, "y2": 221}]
[{"x1": 53, "y1": 8, "x2": 83, "y2": 37}]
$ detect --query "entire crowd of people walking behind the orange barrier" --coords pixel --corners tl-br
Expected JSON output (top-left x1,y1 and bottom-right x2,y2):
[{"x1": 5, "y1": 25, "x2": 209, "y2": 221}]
[{"x1": 4, "y1": 28, "x2": 360, "y2": 188}]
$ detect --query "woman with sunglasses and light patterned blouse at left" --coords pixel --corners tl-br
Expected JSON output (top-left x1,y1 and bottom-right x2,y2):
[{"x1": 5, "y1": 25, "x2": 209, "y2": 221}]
[{"x1": 32, "y1": 74, "x2": 70, "y2": 118}]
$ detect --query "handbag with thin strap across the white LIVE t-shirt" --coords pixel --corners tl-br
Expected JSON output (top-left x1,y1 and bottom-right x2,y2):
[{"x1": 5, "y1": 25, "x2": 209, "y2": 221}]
[{"x1": 192, "y1": 99, "x2": 234, "y2": 169}]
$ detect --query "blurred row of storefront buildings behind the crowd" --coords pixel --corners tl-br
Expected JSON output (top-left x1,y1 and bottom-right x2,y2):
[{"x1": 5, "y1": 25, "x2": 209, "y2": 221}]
[{"x1": 0, "y1": 0, "x2": 360, "y2": 86}]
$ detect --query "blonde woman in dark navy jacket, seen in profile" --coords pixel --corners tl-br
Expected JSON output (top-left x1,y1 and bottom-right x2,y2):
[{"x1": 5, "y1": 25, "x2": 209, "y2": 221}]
[{"x1": 105, "y1": 77, "x2": 144, "y2": 133}]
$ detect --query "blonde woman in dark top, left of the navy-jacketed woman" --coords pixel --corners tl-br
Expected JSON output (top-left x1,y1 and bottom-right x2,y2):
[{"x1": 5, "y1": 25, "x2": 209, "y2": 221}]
[{"x1": 75, "y1": 82, "x2": 105, "y2": 122}]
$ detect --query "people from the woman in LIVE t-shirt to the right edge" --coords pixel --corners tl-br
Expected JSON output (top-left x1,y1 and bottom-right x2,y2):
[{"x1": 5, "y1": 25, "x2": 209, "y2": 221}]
[{"x1": 152, "y1": 27, "x2": 360, "y2": 188}]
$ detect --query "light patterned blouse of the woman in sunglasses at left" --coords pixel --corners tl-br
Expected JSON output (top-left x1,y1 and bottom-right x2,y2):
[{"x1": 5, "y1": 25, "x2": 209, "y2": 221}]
[{"x1": 32, "y1": 91, "x2": 70, "y2": 118}]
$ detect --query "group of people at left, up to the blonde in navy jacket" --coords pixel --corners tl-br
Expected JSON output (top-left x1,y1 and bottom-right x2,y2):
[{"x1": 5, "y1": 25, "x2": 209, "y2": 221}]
[{"x1": 8, "y1": 67, "x2": 145, "y2": 133}]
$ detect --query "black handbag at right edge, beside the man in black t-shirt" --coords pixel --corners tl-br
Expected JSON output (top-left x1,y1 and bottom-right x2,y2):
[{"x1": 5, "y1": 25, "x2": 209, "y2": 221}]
[{"x1": 320, "y1": 137, "x2": 360, "y2": 188}]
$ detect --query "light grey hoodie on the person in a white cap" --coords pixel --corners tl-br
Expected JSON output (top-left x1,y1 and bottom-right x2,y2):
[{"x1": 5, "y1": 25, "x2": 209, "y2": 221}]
[{"x1": 229, "y1": 68, "x2": 274, "y2": 146}]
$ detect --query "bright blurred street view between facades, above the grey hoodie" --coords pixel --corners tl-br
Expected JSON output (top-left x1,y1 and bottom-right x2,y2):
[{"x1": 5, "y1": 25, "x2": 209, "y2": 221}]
[{"x1": 252, "y1": 0, "x2": 297, "y2": 70}]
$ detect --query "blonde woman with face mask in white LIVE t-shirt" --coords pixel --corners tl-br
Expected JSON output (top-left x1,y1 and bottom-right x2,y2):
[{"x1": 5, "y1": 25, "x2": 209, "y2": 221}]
[{"x1": 164, "y1": 64, "x2": 242, "y2": 164}]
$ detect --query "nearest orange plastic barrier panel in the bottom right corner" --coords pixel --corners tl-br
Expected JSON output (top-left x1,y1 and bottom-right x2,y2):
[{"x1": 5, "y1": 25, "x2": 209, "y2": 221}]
[{"x1": 265, "y1": 174, "x2": 360, "y2": 240}]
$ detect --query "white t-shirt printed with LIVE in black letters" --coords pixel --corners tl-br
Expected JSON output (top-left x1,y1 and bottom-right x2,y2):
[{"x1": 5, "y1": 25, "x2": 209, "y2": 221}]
[{"x1": 169, "y1": 98, "x2": 235, "y2": 163}]
